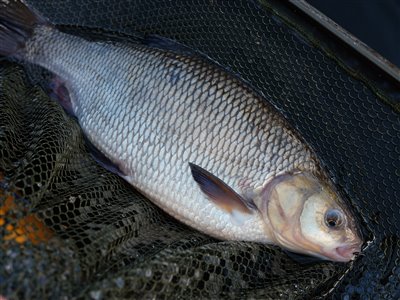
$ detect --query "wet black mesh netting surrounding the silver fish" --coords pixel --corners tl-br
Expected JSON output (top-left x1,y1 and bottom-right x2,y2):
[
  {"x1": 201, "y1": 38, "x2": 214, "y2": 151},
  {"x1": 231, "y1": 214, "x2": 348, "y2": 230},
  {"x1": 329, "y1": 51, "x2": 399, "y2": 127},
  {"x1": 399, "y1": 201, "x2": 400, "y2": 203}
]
[{"x1": 0, "y1": 0, "x2": 400, "y2": 299}]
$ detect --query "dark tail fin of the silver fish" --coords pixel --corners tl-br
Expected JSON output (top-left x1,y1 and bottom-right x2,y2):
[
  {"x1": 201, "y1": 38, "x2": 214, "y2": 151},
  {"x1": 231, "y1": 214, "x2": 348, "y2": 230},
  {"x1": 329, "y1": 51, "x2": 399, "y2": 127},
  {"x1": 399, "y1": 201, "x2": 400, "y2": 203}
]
[{"x1": 0, "y1": 0, "x2": 48, "y2": 57}]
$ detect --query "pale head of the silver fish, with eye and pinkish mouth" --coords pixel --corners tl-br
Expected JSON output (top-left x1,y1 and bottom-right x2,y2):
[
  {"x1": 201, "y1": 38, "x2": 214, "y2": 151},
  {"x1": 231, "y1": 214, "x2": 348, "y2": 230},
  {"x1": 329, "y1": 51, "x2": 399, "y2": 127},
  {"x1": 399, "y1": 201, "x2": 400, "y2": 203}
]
[{"x1": 259, "y1": 172, "x2": 362, "y2": 262}]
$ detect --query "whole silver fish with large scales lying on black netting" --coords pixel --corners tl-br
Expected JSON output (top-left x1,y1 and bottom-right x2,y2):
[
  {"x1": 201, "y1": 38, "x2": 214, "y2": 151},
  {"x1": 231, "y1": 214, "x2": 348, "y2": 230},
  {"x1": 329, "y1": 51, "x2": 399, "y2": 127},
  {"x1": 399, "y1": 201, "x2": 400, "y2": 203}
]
[{"x1": 0, "y1": 0, "x2": 363, "y2": 262}]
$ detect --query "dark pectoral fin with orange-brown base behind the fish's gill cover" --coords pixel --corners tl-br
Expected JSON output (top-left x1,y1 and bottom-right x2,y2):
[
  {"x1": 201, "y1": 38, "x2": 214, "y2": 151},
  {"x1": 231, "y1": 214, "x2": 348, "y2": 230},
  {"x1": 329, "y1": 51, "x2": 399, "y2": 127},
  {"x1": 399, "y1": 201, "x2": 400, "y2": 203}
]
[{"x1": 189, "y1": 163, "x2": 254, "y2": 215}]
